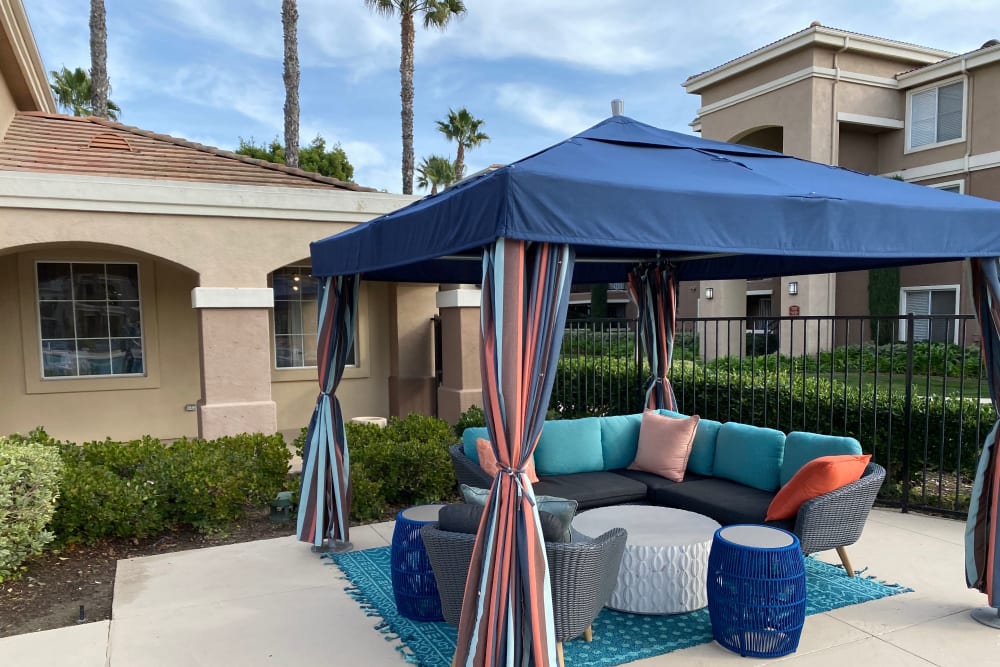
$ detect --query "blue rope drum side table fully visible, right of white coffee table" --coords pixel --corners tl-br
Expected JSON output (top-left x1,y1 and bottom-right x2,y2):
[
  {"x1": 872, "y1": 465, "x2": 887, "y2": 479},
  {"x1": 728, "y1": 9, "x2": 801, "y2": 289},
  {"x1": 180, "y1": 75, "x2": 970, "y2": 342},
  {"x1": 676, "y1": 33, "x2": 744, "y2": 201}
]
[{"x1": 708, "y1": 525, "x2": 806, "y2": 658}]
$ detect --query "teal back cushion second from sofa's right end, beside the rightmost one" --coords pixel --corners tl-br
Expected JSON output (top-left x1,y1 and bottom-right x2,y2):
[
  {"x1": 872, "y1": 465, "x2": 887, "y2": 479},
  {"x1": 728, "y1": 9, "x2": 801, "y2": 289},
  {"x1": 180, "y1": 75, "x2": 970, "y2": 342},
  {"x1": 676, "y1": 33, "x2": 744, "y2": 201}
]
[{"x1": 713, "y1": 422, "x2": 785, "y2": 491}]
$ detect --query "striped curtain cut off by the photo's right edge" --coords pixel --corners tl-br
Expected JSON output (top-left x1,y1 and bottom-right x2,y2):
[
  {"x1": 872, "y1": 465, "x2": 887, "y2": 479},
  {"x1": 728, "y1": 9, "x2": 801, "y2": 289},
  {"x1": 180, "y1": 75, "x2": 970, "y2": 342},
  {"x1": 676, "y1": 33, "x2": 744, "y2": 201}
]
[{"x1": 965, "y1": 258, "x2": 1000, "y2": 607}]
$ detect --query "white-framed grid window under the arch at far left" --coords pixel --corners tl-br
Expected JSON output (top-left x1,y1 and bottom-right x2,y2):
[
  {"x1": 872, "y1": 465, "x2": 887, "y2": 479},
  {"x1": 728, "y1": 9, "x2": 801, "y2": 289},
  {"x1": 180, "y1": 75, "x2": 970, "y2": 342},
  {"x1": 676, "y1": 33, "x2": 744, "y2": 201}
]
[{"x1": 35, "y1": 261, "x2": 146, "y2": 379}]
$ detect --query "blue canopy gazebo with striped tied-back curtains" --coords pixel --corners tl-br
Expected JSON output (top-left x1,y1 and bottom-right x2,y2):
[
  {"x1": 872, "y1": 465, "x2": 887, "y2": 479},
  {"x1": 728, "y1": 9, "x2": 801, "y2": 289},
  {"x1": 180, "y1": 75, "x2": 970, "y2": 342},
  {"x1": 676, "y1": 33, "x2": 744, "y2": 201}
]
[{"x1": 300, "y1": 116, "x2": 1000, "y2": 665}]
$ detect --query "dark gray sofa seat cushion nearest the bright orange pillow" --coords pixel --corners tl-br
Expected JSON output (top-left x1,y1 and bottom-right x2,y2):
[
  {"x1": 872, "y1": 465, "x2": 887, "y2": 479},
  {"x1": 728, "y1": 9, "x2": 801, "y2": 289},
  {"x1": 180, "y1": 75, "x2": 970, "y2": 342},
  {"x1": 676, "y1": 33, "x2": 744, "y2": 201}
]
[{"x1": 650, "y1": 477, "x2": 774, "y2": 526}]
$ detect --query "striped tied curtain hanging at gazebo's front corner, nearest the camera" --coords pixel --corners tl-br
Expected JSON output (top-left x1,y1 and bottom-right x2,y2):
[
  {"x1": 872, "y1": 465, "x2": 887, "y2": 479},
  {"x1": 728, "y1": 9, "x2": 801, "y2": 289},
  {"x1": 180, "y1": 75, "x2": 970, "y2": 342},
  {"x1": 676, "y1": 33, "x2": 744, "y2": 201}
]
[{"x1": 454, "y1": 239, "x2": 573, "y2": 667}]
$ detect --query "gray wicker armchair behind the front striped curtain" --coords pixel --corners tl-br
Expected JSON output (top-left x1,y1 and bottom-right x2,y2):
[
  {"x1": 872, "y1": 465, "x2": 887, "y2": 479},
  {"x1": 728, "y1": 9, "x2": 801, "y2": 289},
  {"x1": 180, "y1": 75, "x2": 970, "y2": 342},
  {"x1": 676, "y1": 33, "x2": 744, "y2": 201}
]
[{"x1": 420, "y1": 522, "x2": 627, "y2": 665}]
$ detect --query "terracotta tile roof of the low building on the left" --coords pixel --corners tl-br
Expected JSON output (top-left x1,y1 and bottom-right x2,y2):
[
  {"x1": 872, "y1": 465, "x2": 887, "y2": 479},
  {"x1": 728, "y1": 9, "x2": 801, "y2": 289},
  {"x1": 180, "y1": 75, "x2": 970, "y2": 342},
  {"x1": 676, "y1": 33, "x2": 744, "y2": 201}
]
[{"x1": 0, "y1": 111, "x2": 374, "y2": 192}]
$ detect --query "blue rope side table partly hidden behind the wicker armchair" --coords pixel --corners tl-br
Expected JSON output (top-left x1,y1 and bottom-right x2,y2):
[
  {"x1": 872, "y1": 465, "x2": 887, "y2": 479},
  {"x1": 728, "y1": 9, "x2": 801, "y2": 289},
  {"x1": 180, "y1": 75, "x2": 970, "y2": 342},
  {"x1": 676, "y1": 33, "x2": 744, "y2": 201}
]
[{"x1": 390, "y1": 505, "x2": 444, "y2": 621}]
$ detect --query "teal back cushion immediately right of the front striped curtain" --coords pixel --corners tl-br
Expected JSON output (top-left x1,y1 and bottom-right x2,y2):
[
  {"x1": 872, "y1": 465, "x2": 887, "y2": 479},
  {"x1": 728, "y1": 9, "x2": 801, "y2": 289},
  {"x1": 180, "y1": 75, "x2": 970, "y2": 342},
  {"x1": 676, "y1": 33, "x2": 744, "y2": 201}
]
[{"x1": 535, "y1": 417, "x2": 604, "y2": 475}]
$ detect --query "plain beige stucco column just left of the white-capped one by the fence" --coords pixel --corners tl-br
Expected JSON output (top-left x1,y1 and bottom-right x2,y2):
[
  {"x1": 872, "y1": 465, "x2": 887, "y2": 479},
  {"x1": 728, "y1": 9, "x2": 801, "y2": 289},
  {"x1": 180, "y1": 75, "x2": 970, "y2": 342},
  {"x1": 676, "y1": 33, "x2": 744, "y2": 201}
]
[{"x1": 388, "y1": 283, "x2": 438, "y2": 417}]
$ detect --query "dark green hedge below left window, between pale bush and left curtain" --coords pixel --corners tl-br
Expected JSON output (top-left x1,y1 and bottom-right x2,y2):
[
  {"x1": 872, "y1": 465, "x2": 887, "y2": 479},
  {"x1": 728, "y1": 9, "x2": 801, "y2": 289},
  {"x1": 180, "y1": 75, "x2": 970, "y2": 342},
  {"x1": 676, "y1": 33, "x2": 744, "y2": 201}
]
[{"x1": 10, "y1": 429, "x2": 291, "y2": 544}]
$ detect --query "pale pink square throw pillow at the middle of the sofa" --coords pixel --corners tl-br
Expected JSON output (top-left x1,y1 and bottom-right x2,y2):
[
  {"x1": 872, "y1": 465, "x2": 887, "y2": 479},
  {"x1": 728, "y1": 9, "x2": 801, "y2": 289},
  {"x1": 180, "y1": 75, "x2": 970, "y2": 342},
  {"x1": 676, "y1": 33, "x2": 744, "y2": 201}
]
[{"x1": 628, "y1": 410, "x2": 699, "y2": 482}]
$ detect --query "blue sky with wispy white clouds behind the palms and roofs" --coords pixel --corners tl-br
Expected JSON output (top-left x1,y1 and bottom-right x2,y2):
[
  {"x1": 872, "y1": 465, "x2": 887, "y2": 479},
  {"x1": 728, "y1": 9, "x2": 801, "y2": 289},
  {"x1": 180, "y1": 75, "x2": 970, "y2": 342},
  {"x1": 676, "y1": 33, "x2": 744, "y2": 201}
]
[{"x1": 23, "y1": 0, "x2": 1000, "y2": 194}]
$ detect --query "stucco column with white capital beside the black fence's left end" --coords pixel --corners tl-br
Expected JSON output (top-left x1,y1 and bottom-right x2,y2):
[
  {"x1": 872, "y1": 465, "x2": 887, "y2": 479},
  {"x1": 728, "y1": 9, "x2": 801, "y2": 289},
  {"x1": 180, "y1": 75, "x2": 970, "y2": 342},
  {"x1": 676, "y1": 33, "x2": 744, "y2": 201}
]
[{"x1": 437, "y1": 286, "x2": 483, "y2": 424}]
